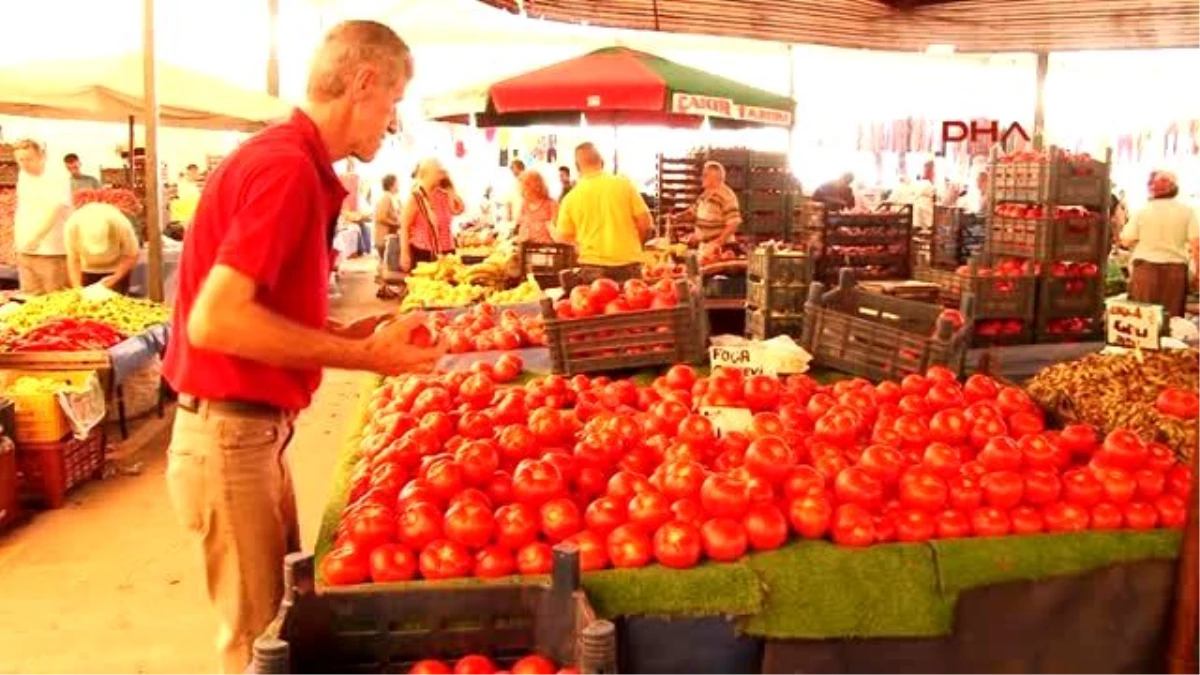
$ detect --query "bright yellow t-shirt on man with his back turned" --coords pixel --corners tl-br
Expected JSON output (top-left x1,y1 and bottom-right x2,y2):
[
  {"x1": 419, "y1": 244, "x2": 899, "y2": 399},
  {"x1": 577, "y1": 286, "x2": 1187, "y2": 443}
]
[{"x1": 558, "y1": 171, "x2": 650, "y2": 267}]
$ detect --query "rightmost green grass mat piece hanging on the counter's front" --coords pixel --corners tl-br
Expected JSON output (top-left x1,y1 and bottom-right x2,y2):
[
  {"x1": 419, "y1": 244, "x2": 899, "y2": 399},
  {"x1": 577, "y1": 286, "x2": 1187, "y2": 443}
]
[{"x1": 929, "y1": 530, "x2": 1180, "y2": 602}]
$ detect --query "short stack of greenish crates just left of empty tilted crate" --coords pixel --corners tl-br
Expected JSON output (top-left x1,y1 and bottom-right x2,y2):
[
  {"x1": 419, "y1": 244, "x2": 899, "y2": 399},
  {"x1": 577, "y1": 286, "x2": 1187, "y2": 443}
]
[{"x1": 746, "y1": 244, "x2": 812, "y2": 340}]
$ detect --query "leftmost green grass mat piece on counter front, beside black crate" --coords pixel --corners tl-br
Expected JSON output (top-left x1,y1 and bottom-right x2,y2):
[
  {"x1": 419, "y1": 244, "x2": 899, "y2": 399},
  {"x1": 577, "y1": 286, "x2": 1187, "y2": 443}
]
[{"x1": 583, "y1": 561, "x2": 763, "y2": 619}]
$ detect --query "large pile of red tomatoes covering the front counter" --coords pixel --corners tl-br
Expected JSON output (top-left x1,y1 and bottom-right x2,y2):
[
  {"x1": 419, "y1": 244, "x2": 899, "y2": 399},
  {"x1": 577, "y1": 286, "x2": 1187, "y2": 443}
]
[{"x1": 322, "y1": 366, "x2": 1192, "y2": 585}]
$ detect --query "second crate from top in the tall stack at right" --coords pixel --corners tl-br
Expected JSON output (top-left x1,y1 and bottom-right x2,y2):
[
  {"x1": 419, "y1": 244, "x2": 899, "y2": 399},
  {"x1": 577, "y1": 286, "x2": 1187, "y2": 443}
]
[{"x1": 988, "y1": 205, "x2": 1109, "y2": 263}]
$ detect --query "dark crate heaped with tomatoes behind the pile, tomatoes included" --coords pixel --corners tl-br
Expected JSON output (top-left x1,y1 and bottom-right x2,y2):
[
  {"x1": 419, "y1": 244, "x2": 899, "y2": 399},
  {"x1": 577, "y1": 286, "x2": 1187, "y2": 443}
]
[{"x1": 541, "y1": 279, "x2": 708, "y2": 375}]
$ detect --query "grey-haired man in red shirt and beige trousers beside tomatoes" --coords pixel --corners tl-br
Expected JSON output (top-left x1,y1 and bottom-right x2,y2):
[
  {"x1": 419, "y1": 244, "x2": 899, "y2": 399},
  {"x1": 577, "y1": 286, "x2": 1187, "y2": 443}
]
[{"x1": 163, "y1": 20, "x2": 442, "y2": 675}]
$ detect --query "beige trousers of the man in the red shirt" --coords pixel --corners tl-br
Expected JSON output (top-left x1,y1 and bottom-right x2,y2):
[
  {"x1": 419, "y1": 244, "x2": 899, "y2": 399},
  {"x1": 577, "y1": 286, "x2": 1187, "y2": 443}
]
[{"x1": 167, "y1": 404, "x2": 300, "y2": 675}]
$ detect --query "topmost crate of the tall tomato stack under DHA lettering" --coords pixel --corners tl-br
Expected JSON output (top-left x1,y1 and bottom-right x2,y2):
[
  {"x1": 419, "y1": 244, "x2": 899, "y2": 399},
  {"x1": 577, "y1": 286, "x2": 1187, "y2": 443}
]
[{"x1": 989, "y1": 147, "x2": 1112, "y2": 211}]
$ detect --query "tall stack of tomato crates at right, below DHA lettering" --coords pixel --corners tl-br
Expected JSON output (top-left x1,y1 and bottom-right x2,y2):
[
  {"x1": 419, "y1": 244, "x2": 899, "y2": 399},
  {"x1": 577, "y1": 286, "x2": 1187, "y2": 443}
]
[{"x1": 988, "y1": 147, "x2": 1112, "y2": 344}]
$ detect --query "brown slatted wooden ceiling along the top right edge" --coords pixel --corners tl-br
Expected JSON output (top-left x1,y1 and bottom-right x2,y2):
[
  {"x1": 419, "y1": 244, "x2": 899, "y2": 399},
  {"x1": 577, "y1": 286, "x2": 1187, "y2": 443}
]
[{"x1": 479, "y1": 0, "x2": 1200, "y2": 52}]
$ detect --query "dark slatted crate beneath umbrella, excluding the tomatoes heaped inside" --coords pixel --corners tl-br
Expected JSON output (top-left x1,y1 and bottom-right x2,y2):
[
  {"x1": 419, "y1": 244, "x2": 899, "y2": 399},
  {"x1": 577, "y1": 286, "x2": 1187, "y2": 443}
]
[{"x1": 541, "y1": 280, "x2": 708, "y2": 375}]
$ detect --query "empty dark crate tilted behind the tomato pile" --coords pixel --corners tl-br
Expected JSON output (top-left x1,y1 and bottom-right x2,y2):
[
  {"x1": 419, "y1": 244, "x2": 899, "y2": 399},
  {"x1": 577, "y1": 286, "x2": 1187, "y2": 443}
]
[{"x1": 800, "y1": 270, "x2": 973, "y2": 380}]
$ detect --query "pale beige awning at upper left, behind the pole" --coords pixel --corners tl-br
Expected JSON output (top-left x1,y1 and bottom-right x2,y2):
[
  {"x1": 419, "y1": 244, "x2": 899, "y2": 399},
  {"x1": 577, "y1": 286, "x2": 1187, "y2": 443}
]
[{"x1": 0, "y1": 54, "x2": 290, "y2": 131}]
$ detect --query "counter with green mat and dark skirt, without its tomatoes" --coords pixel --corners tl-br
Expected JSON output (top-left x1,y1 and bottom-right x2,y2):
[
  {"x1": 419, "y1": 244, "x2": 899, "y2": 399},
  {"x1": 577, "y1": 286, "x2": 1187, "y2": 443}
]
[{"x1": 317, "y1": 372, "x2": 1180, "y2": 675}]
